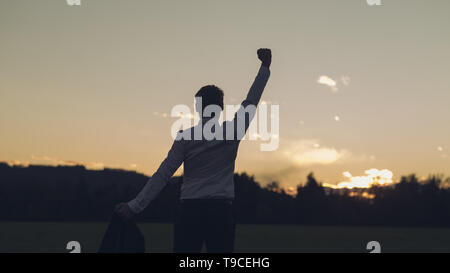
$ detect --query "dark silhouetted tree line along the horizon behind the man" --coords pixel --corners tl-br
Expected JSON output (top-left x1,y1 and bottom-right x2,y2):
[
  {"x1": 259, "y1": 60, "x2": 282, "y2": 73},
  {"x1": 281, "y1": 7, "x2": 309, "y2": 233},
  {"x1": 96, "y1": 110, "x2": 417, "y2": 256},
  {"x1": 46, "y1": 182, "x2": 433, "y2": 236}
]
[{"x1": 0, "y1": 163, "x2": 450, "y2": 226}]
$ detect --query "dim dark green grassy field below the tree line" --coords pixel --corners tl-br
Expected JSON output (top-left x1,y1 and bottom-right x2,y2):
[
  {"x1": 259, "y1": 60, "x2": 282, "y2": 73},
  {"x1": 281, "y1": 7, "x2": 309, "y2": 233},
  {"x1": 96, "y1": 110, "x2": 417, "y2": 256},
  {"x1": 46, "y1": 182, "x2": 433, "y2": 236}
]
[{"x1": 0, "y1": 222, "x2": 450, "y2": 252}]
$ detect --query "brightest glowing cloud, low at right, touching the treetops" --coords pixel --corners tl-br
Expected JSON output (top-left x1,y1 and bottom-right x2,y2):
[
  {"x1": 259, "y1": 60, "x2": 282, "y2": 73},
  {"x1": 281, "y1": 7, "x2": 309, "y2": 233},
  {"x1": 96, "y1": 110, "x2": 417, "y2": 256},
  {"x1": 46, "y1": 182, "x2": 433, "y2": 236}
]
[{"x1": 324, "y1": 168, "x2": 394, "y2": 189}]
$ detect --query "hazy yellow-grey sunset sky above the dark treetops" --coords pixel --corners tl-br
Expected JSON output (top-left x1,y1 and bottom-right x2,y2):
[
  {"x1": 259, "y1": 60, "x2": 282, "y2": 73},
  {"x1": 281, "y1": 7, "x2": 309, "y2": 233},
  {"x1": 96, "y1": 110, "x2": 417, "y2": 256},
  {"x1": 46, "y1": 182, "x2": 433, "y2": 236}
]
[{"x1": 0, "y1": 0, "x2": 450, "y2": 187}]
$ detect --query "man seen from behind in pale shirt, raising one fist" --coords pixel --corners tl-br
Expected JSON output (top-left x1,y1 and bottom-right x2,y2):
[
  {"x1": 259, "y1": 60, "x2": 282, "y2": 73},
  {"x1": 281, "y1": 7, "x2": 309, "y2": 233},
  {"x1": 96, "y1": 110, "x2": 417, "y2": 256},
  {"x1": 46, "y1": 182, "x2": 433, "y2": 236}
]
[{"x1": 116, "y1": 48, "x2": 272, "y2": 253}]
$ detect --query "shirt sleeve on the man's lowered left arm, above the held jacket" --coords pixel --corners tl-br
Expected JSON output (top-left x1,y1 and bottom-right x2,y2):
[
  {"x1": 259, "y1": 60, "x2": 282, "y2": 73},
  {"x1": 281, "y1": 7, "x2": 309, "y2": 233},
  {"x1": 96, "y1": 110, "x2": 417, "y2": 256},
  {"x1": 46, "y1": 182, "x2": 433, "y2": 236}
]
[{"x1": 128, "y1": 136, "x2": 184, "y2": 213}]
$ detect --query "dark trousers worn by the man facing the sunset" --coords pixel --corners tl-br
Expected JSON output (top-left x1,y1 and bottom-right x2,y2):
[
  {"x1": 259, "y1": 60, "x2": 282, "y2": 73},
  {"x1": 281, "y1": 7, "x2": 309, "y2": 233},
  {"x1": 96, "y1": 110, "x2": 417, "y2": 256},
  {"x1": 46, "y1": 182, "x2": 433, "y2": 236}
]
[{"x1": 174, "y1": 199, "x2": 235, "y2": 253}]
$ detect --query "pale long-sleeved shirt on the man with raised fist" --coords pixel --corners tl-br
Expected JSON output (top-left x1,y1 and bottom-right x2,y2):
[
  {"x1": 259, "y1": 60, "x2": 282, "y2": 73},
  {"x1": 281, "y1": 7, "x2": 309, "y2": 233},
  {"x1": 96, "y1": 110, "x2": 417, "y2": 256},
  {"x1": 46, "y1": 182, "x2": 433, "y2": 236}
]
[{"x1": 128, "y1": 66, "x2": 270, "y2": 213}]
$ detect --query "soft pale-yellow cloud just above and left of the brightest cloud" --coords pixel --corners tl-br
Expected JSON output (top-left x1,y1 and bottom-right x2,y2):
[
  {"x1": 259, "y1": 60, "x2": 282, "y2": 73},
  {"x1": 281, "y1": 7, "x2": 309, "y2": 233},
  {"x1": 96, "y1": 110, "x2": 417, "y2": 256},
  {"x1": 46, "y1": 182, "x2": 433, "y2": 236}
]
[{"x1": 283, "y1": 139, "x2": 350, "y2": 166}]
